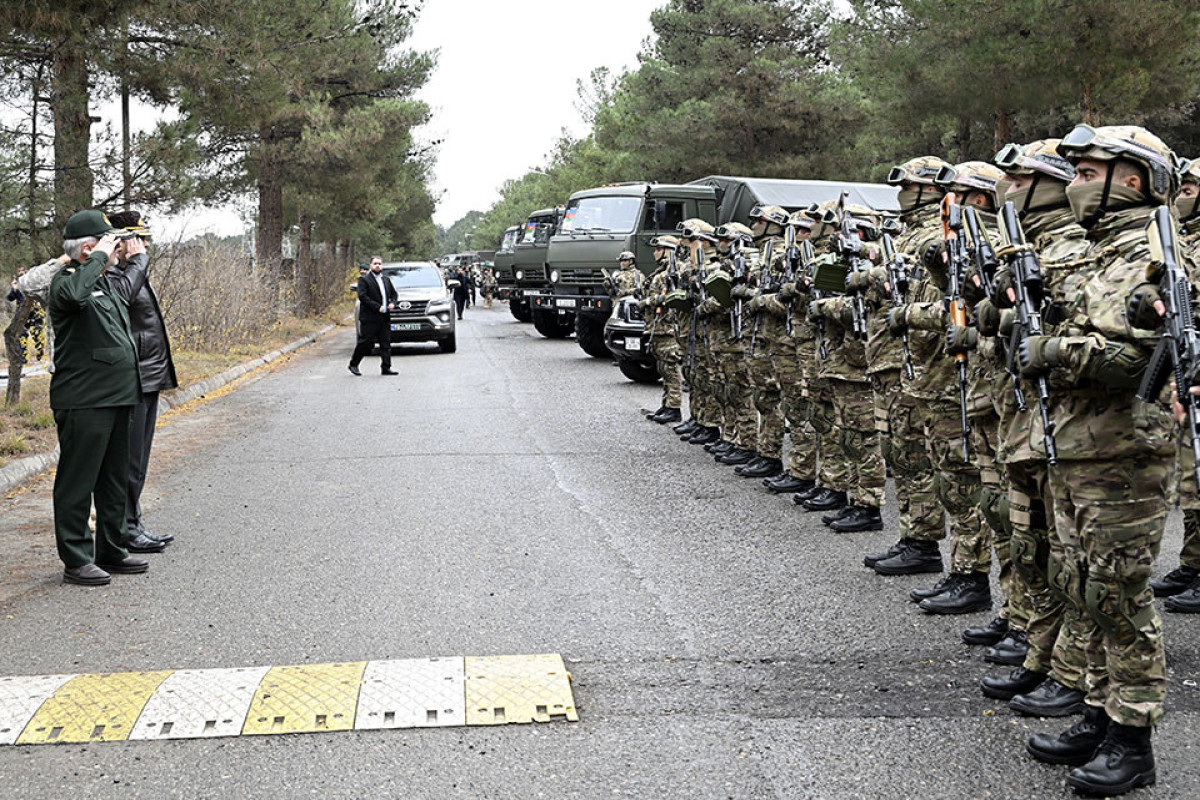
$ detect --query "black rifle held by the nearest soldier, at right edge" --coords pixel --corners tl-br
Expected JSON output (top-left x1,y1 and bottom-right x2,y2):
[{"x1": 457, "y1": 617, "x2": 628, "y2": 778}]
[{"x1": 1138, "y1": 205, "x2": 1200, "y2": 483}]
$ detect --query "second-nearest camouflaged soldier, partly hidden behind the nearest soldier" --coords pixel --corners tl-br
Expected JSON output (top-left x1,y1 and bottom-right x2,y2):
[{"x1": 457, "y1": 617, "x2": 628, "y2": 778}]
[{"x1": 976, "y1": 139, "x2": 1088, "y2": 716}]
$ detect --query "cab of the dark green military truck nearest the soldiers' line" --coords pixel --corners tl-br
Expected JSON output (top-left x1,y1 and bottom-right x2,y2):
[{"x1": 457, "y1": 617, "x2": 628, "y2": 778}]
[{"x1": 547, "y1": 182, "x2": 718, "y2": 359}]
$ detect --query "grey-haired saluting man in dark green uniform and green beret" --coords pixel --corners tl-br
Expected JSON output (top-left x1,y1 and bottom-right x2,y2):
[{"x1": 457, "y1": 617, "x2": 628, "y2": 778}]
[{"x1": 49, "y1": 210, "x2": 150, "y2": 585}]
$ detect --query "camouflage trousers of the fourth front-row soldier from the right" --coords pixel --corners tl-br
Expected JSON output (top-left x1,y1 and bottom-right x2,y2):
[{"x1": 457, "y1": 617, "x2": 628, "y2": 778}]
[{"x1": 924, "y1": 401, "x2": 991, "y2": 575}]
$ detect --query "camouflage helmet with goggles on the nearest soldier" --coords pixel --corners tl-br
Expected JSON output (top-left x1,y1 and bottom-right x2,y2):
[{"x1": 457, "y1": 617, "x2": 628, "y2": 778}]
[{"x1": 1058, "y1": 125, "x2": 1180, "y2": 203}]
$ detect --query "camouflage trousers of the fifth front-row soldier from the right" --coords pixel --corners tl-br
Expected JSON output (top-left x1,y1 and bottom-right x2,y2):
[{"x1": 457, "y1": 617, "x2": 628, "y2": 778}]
[{"x1": 871, "y1": 379, "x2": 946, "y2": 542}]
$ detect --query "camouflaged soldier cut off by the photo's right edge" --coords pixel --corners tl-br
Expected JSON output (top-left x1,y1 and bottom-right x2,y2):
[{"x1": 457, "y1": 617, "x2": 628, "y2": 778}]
[{"x1": 1150, "y1": 158, "x2": 1200, "y2": 614}]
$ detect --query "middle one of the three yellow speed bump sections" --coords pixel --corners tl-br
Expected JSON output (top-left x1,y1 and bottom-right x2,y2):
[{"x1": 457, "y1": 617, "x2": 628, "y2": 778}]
[{"x1": 241, "y1": 661, "x2": 367, "y2": 736}]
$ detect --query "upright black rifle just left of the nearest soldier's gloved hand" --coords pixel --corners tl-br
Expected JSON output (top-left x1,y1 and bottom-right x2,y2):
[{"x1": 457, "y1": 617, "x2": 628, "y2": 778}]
[{"x1": 998, "y1": 201, "x2": 1058, "y2": 464}]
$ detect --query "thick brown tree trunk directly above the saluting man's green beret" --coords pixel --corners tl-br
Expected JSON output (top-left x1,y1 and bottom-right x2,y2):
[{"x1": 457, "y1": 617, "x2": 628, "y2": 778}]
[{"x1": 53, "y1": 40, "x2": 92, "y2": 228}]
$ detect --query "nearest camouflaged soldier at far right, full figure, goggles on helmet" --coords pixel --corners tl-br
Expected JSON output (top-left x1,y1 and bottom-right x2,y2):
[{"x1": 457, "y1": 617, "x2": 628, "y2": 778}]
[{"x1": 1018, "y1": 125, "x2": 1178, "y2": 794}]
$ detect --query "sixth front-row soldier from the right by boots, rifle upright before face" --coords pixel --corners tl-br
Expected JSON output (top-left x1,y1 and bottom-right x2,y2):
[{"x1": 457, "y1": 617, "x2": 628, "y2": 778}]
[{"x1": 809, "y1": 205, "x2": 887, "y2": 533}]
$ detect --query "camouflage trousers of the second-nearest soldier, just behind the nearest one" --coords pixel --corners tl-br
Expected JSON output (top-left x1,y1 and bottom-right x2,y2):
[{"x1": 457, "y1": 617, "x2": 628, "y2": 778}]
[{"x1": 1008, "y1": 461, "x2": 1087, "y2": 688}]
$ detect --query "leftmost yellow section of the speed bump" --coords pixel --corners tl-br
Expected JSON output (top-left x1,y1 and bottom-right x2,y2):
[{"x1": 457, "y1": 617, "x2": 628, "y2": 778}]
[{"x1": 17, "y1": 669, "x2": 173, "y2": 745}]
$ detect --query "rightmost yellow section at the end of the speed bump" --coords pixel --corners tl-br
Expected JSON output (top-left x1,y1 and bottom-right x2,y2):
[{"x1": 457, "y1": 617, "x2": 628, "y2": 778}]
[{"x1": 464, "y1": 654, "x2": 580, "y2": 726}]
